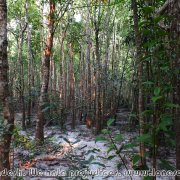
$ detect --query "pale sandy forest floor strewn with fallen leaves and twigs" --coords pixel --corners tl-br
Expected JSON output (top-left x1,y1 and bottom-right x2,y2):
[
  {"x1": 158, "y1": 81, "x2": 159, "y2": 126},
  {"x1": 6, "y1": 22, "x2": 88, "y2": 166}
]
[{"x1": 12, "y1": 108, "x2": 173, "y2": 180}]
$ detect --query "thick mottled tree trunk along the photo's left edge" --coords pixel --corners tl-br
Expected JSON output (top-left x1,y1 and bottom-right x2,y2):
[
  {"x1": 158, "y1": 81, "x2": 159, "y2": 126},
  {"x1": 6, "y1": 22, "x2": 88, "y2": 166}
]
[{"x1": 0, "y1": 0, "x2": 14, "y2": 180}]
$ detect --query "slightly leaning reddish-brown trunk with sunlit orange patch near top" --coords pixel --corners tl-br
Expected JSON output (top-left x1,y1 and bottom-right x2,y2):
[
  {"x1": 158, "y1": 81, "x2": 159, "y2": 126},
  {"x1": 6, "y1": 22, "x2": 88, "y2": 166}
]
[{"x1": 36, "y1": 0, "x2": 55, "y2": 142}]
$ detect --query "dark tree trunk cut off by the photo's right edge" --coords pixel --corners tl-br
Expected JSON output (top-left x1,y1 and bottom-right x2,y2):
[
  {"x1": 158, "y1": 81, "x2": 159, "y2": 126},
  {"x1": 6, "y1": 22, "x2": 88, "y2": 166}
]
[{"x1": 171, "y1": 0, "x2": 180, "y2": 177}]
